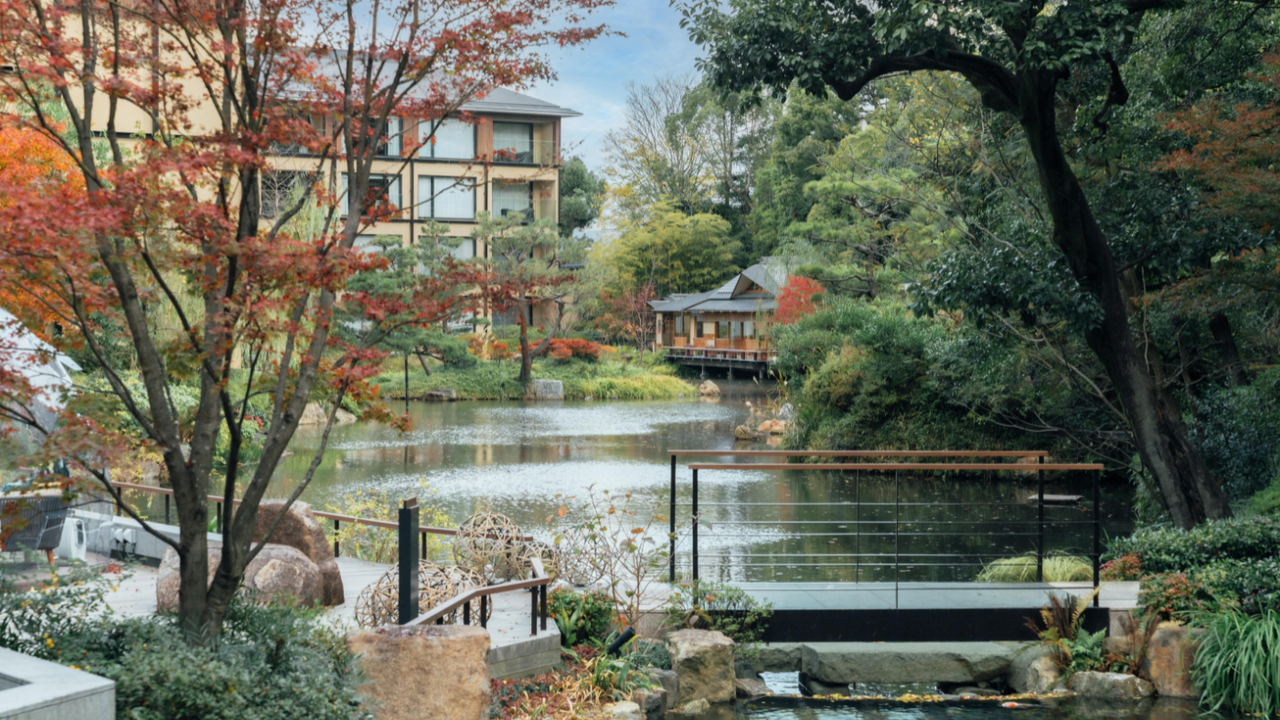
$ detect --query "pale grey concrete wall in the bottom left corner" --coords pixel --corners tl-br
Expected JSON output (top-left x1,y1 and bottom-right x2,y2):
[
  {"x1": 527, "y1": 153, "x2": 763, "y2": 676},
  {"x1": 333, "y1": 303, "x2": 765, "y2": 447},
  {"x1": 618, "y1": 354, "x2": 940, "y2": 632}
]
[{"x1": 0, "y1": 648, "x2": 115, "y2": 720}]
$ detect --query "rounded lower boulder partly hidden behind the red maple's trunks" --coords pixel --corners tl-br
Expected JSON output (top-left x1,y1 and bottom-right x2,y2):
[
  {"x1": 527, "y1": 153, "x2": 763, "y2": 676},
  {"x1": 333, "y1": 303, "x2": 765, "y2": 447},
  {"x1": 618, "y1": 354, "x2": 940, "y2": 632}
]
[{"x1": 156, "y1": 543, "x2": 324, "y2": 611}]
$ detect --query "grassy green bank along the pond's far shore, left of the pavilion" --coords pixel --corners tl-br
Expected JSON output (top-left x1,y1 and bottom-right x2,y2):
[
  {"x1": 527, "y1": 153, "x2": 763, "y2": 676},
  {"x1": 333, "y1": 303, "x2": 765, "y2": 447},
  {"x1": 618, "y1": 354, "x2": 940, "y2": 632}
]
[{"x1": 374, "y1": 359, "x2": 698, "y2": 400}]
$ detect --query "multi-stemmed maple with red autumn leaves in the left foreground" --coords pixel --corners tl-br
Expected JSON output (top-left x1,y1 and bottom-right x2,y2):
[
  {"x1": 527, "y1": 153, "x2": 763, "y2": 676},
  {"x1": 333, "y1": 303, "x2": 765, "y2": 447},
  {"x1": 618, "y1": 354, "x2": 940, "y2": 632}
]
[{"x1": 0, "y1": 0, "x2": 608, "y2": 643}]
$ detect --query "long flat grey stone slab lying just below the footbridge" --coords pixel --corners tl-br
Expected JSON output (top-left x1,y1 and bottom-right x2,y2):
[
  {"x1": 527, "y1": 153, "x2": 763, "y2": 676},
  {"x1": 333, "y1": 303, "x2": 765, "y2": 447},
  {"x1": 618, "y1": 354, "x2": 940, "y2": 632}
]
[{"x1": 801, "y1": 642, "x2": 1014, "y2": 684}]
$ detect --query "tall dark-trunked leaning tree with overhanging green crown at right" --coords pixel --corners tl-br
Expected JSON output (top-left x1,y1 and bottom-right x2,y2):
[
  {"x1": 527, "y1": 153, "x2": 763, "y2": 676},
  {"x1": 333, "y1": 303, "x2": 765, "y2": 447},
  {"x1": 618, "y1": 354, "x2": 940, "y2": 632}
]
[{"x1": 682, "y1": 0, "x2": 1263, "y2": 528}]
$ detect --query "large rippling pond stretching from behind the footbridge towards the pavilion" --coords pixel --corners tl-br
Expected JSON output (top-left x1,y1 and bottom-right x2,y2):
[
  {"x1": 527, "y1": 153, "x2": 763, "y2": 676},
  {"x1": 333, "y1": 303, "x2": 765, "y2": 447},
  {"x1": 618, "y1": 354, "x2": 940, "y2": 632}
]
[{"x1": 264, "y1": 383, "x2": 1130, "y2": 582}]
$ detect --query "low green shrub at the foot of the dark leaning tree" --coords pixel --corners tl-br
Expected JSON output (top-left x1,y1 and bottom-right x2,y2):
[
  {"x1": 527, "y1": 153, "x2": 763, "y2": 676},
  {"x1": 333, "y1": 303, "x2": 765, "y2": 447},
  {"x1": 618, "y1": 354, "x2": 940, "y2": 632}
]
[{"x1": 1105, "y1": 518, "x2": 1280, "y2": 574}]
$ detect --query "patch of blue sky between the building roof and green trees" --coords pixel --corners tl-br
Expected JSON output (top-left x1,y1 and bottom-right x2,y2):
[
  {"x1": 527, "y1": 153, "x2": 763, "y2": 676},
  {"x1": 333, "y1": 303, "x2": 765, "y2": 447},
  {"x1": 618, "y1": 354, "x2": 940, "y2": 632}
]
[{"x1": 525, "y1": 0, "x2": 699, "y2": 172}]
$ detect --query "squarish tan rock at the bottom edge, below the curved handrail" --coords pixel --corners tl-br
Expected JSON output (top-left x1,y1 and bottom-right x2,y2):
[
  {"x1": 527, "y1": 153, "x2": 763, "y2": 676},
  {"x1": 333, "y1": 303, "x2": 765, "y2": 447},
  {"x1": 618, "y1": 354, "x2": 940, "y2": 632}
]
[{"x1": 347, "y1": 625, "x2": 490, "y2": 720}]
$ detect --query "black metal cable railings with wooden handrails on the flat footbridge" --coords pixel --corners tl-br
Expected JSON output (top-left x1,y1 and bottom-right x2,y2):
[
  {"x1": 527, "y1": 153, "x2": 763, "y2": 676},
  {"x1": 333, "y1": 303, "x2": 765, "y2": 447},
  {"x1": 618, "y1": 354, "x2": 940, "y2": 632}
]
[{"x1": 669, "y1": 450, "x2": 1102, "y2": 605}]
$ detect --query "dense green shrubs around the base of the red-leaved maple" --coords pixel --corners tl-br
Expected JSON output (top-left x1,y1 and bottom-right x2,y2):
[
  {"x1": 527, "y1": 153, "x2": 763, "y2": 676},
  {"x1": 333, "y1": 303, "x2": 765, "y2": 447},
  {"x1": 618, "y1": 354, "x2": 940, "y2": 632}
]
[{"x1": 0, "y1": 566, "x2": 370, "y2": 720}]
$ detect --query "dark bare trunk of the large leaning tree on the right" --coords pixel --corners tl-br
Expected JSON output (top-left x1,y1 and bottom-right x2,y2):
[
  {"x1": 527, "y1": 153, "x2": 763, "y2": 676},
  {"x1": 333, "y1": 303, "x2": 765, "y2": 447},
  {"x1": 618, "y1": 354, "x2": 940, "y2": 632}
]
[{"x1": 1019, "y1": 70, "x2": 1231, "y2": 528}]
